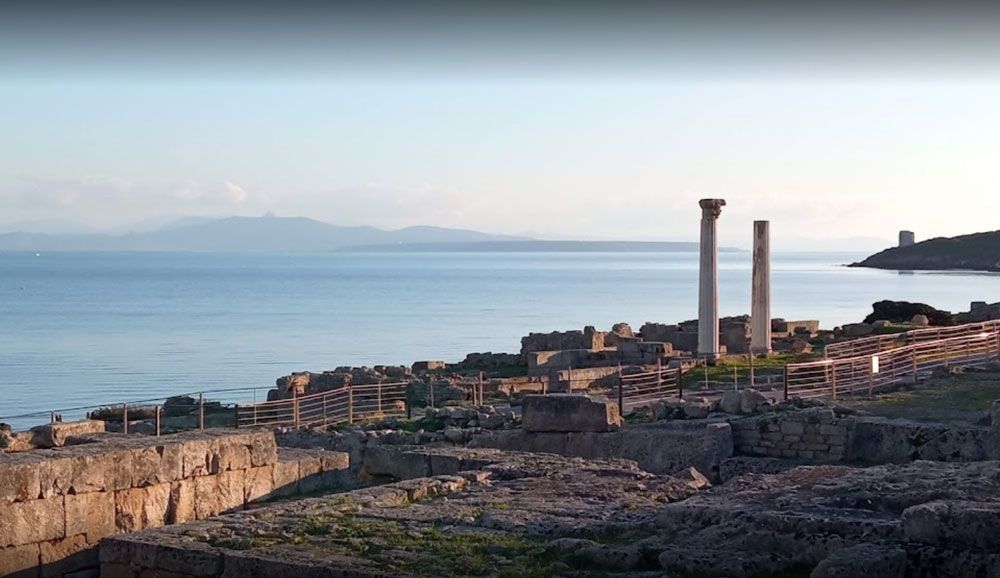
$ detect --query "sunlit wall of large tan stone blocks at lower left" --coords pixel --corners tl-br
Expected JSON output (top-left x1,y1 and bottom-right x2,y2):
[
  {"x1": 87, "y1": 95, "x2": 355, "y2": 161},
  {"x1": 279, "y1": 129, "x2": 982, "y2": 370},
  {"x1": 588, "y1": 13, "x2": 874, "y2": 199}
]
[{"x1": 0, "y1": 430, "x2": 348, "y2": 578}]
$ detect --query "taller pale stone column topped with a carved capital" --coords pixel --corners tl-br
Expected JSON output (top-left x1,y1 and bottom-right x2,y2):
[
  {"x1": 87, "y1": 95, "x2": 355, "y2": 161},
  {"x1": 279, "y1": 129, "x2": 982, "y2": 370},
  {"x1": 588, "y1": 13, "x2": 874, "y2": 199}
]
[{"x1": 698, "y1": 199, "x2": 726, "y2": 361}]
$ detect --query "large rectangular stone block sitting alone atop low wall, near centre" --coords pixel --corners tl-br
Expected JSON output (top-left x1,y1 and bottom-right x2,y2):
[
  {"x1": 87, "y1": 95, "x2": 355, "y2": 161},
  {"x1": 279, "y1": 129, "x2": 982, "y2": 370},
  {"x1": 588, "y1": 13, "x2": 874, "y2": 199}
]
[{"x1": 522, "y1": 394, "x2": 622, "y2": 432}]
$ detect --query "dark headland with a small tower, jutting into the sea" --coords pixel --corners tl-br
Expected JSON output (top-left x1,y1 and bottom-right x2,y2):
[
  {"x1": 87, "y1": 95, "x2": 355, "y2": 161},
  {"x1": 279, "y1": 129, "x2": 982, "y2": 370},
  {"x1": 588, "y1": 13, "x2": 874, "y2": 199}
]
[{"x1": 850, "y1": 231, "x2": 1000, "y2": 272}]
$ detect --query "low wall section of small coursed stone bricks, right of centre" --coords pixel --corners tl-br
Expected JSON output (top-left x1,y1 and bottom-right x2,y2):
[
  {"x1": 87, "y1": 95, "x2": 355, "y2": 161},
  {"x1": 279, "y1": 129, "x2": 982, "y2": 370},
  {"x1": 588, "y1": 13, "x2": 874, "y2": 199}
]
[{"x1": 730, "y1": 408, "x2": 848, "y2": 463}]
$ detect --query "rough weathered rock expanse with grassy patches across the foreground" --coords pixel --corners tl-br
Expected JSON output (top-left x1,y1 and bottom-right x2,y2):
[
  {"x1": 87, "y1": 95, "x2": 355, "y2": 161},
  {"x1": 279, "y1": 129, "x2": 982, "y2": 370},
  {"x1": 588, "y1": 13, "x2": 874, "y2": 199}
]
[{"x1": 101, "y1": 448, "x2": 1000, "y2": 578}]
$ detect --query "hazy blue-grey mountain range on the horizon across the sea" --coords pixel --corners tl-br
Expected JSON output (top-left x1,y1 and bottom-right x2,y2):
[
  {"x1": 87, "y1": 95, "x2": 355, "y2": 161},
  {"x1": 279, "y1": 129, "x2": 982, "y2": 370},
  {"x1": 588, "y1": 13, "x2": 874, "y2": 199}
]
[{"x1": 0, "y1": 216, "x2": 726, "y2": 252}]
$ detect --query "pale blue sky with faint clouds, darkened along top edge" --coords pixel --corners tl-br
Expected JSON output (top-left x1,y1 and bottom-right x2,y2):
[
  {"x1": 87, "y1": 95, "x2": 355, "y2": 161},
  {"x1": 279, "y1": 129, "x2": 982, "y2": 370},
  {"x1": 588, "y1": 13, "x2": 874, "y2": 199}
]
[{"x1": 0, "y1": 0, "x2": 1000, "y2": 250}]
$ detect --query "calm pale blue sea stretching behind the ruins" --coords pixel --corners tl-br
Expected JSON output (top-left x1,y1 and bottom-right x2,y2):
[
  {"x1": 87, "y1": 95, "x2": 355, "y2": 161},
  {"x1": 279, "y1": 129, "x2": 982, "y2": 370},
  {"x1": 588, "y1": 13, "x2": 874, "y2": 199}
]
[{"x1": 0, "y1": 253, "x2": 1000, "y2": 426}]
